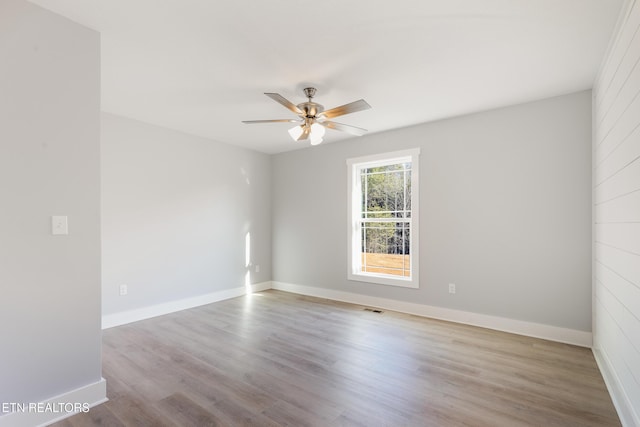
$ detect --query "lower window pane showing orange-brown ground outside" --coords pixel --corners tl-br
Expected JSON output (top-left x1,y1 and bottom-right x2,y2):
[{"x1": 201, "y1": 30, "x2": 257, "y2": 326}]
[{"x1": 361, "y1": 222, "x2": 411, "y2": 277}]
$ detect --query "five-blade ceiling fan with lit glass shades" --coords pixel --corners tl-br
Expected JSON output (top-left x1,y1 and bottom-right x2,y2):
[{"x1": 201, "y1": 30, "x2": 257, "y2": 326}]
[{"x1": 242, "y1": 87, "x2": 371, "y2": 145}]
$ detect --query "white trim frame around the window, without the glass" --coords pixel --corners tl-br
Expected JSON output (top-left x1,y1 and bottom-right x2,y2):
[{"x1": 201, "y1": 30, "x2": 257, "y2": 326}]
[{"x1": 347, "y1": 148, "x2": 420, "y2": 288}]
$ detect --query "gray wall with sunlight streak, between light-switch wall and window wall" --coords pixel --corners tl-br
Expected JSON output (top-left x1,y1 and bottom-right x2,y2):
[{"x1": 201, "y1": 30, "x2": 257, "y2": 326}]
[{"x1": 102, "y1": 113, "x2": 271, "y2": 315}]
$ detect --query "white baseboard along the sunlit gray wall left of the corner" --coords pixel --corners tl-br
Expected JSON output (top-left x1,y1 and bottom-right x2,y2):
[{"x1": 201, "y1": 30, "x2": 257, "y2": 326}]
[{"x1": 102, "y1": 282, "x2": 271, "y2": 329}]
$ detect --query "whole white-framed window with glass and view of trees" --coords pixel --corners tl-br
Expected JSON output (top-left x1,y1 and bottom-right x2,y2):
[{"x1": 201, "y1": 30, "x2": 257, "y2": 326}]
[{"x1": 347, "y1": 149, "x2": 420, "y2": 288}]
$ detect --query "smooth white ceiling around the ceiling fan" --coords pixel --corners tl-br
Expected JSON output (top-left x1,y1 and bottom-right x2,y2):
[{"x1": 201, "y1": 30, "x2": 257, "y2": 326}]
[{"x1": 27, "y1": 0, "x2": 623, "y2": 153}]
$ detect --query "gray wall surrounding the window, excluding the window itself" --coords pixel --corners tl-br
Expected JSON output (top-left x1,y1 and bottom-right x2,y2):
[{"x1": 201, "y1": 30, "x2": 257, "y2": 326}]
[{"x1": 272, "y1": 91, "x2": 591, "y2": 331}]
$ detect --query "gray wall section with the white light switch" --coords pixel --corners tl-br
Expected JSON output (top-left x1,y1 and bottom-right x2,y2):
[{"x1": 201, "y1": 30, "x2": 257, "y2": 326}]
[{"x1": 0, "y1": 0, "x2": 101, "y2": 408}]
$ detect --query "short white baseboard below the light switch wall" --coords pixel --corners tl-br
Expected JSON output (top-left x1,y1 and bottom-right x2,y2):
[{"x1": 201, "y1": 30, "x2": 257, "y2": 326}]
[{"x1": 0, "y1": 378, "x2": 108, "y2": 427}]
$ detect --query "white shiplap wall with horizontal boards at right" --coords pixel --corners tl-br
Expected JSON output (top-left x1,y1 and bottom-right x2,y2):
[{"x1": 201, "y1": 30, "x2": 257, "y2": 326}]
[{"x1": 593, "y1": 0, "x2": 640, "y2": 426}]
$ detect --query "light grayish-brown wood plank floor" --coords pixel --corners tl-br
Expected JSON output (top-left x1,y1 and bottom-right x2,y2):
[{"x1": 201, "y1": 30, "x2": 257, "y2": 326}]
[{"x1": 55, "y1": 290, "x2": 620, "y2": 427}]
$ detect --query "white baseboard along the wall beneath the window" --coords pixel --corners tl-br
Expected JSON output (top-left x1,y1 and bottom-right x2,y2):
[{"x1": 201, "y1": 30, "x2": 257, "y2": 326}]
[{"x1": 271, "y1": 281, "x2": 592, "y2": 348}]
